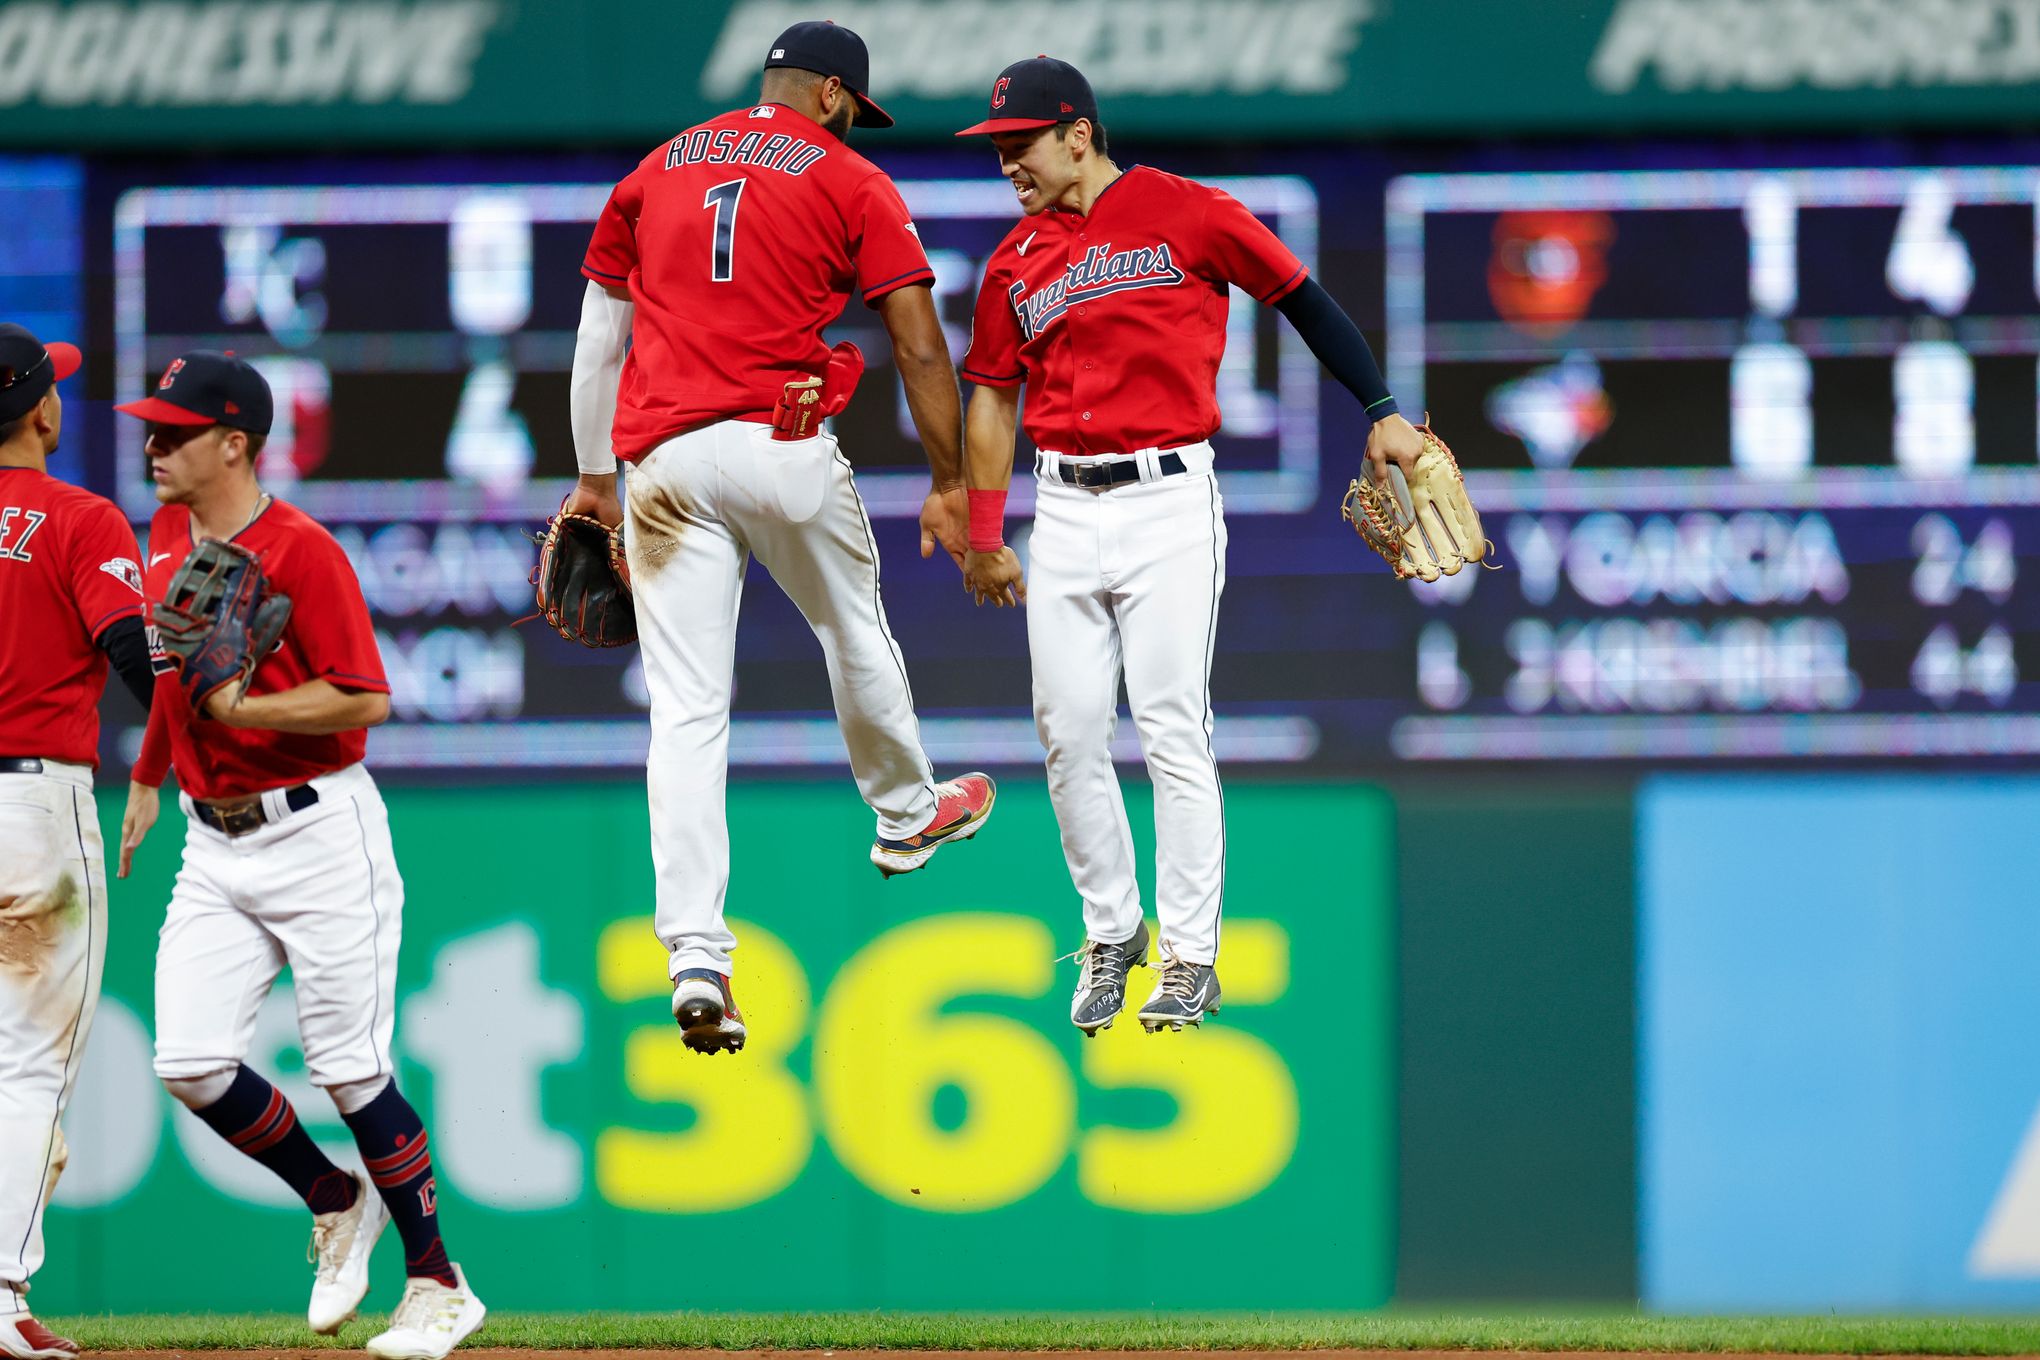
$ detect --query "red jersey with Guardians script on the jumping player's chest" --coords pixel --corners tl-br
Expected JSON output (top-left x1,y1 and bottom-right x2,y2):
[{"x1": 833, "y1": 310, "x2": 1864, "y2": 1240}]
[{"x1": 963, "y1": 165, "x2": 1308, "y2": 455}]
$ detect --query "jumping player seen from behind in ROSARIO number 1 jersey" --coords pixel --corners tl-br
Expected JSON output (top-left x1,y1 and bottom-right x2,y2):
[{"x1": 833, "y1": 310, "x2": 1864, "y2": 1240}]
[{"x1": 567, "y1": 22, "x2": 993, "y2": 1052}]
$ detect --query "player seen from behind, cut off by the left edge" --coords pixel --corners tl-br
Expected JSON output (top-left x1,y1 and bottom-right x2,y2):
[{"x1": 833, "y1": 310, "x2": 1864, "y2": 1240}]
[{"x1": 0, "y1": 324, "x2": 155, "y2": 1358}]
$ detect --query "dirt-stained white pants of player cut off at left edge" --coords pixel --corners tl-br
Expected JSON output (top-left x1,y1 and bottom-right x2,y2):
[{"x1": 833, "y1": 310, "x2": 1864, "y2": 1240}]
[{"x1": 0, "y1": 761, "x2": 106, "y2": 1313}]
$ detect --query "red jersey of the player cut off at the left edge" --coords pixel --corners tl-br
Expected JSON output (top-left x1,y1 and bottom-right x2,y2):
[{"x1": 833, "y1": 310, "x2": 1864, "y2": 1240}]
[{"x1": 0, "y1": 467, "x2": 141, "y2": 765}]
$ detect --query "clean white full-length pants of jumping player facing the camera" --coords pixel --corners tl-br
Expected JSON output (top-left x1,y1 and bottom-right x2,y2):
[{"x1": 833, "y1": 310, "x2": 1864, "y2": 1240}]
[{"x1": 1026, "y1": 442, "x2": 1226, "y2": 964}]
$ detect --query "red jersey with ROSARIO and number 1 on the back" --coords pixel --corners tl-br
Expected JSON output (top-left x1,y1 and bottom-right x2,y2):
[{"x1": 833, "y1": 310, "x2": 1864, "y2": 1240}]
[{"x1": 581, "y1": 104, "x2": 934, "y2": 459}]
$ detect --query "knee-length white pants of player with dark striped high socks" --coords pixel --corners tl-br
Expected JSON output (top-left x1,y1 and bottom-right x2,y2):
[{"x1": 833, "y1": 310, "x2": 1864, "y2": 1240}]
[{"x1": 155, "y1": 765, "x2": 404, "y2": 1087}]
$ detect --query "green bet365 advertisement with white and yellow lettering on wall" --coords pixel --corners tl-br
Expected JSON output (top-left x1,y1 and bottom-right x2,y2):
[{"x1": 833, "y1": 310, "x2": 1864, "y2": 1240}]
[{"x1": 35, "y1": 781, "x2": 1393, "y2": 1313}]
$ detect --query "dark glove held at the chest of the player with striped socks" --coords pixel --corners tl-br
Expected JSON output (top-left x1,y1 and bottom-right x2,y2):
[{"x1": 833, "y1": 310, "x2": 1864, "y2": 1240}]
[{"x1": 149, "y1": 538, "x2": 290, "y2": 714}]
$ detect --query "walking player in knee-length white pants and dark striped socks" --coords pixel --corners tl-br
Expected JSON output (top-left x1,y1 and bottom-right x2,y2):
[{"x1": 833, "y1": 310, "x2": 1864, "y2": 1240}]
[{"x1": 116, "y1": 351, "x2": 486, "y2": 1360}]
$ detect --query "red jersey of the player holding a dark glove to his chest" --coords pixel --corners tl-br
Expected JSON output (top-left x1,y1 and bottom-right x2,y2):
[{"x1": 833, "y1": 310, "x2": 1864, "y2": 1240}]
[{"x1": 135, "y1": 500, "x2": 390, "y2": 799}]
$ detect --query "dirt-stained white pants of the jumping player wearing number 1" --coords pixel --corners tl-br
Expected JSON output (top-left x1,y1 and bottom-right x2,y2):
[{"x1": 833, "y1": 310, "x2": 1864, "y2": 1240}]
[{"x1": 624, "y1": 420, "x2": 936, "y2": 977}]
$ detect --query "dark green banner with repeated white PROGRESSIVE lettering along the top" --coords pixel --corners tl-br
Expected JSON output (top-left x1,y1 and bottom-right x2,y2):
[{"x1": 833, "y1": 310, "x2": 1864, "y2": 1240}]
[{"x1": 0, "y1": 0, "x2": 2040, "y2": 151}]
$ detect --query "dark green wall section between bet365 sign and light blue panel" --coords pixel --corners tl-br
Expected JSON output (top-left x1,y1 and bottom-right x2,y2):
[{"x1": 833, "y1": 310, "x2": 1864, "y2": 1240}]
[{"x1": 1395, "y1": 779, "x2": 1636, "y2": 1303}]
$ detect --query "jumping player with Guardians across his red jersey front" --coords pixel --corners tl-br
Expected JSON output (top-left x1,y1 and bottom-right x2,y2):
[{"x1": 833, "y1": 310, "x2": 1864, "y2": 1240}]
[{"x1": 959, "y1": 57, "x2": 1422, "y2": 1034}]
